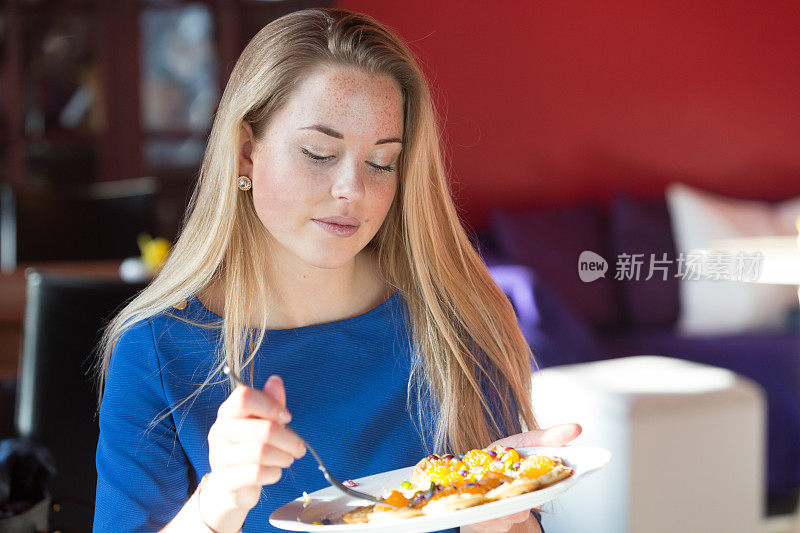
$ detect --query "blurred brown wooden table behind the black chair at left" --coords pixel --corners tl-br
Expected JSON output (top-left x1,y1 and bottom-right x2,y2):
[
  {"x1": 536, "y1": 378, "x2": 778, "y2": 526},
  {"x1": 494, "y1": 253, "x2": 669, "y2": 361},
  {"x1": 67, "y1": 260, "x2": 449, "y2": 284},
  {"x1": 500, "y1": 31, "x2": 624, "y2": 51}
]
[{"x1": 0, "y1": 260, "x2": 122, "y2": 379}]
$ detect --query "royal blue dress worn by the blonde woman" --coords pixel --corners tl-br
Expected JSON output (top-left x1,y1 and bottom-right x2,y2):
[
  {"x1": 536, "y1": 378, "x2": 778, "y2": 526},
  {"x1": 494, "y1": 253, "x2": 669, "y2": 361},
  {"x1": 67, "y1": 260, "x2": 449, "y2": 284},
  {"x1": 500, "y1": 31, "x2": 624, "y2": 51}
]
[{"x1": 94, "y1": 293, "x2": 457, "y2": 533}]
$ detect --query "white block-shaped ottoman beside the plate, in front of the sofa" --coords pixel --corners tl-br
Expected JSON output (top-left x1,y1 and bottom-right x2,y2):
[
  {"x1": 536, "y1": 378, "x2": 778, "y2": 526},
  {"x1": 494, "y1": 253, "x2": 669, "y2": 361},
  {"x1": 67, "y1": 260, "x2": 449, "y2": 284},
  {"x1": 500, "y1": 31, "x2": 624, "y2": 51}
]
[{"x1": 532, "y1": 356, "x2": 766, "y2": 533}]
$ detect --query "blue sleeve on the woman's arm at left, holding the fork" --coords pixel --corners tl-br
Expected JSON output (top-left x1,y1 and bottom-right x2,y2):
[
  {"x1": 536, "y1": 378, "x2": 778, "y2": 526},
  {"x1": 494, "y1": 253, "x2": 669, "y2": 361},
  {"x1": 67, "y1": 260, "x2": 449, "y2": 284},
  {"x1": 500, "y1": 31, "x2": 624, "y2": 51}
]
[{"x1": 94, "y1": 321, "x2": 190, "y2": 531}]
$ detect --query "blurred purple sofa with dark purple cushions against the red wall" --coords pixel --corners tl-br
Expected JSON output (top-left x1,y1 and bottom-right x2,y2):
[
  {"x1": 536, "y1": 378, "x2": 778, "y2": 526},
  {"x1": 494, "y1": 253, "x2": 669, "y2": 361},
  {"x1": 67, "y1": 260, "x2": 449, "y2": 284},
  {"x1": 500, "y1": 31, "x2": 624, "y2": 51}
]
[{"x1": 479, "y1": 196, "x2": 800, "y2": 512}]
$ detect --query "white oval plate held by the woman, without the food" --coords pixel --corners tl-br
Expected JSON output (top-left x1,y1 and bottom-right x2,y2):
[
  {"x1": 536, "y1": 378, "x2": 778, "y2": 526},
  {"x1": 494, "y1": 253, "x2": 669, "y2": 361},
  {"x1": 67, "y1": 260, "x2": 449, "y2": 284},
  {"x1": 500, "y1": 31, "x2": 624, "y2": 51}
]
[{"x1": 269, "y1": 446, "x2": 611, "y2": 533}]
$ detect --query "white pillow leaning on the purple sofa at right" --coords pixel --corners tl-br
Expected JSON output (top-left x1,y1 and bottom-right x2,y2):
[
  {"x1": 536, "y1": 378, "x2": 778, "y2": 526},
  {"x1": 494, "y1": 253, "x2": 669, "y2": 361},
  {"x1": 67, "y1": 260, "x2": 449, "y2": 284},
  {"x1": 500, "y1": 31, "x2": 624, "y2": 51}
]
[{"x1": 666, "y1": 183, "x2": 800, "y2": 335}]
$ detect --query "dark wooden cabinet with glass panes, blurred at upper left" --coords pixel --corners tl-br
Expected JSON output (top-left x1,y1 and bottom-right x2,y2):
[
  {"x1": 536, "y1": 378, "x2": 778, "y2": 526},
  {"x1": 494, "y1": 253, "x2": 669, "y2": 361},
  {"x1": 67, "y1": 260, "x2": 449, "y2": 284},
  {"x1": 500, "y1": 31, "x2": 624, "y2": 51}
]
[{"x1": 0, "y1": 0, "x2": 331, "y2": 237}]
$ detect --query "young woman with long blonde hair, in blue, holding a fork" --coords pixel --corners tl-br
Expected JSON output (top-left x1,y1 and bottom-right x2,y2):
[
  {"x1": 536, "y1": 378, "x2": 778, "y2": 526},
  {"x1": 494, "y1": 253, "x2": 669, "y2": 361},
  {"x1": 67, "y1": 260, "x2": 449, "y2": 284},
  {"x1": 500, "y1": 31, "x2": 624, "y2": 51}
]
[{"x1": 95, "y1": 9, "x2": 580, "y2": 533}]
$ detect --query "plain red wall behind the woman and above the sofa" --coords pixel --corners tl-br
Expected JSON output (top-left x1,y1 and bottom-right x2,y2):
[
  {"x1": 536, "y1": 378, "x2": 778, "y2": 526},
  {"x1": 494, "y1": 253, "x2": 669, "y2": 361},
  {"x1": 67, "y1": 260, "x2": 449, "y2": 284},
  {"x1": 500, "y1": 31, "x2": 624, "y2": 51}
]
[{"x1": 338, "y1": 0, "x2": 800, "y2": 226}]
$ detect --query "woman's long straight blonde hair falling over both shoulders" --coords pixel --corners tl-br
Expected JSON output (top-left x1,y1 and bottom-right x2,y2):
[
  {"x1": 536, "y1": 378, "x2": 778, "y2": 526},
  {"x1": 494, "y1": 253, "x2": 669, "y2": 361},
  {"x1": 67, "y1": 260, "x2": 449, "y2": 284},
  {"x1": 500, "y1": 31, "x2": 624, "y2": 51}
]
[{"x1": 97, "y1": 9, "x2": 536, "y2": 451}]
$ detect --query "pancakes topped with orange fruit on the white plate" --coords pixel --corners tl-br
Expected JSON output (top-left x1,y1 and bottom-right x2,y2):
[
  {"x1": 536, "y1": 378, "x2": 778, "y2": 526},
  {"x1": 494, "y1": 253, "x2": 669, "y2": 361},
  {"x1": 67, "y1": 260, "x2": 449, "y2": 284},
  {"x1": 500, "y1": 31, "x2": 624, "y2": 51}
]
[{"x1": 342, "y1": 445, "x2": 573, "y2": 524}]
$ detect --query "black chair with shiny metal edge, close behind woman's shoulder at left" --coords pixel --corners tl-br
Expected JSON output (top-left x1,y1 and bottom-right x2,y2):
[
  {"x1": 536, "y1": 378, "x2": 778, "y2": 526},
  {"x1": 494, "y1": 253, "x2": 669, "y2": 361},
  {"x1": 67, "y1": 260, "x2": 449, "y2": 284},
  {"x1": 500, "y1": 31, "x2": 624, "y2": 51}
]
[{"x1": 14, "y1": 271, "x2": 143, "y2": 533}]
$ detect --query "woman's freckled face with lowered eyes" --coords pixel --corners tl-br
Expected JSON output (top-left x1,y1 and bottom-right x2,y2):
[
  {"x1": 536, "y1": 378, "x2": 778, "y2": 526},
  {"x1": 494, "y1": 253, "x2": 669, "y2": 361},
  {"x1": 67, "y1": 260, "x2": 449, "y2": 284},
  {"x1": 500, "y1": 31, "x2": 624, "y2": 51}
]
[{"x1": 239, "y1": 67, "x2": 403, "y2": 268}]
